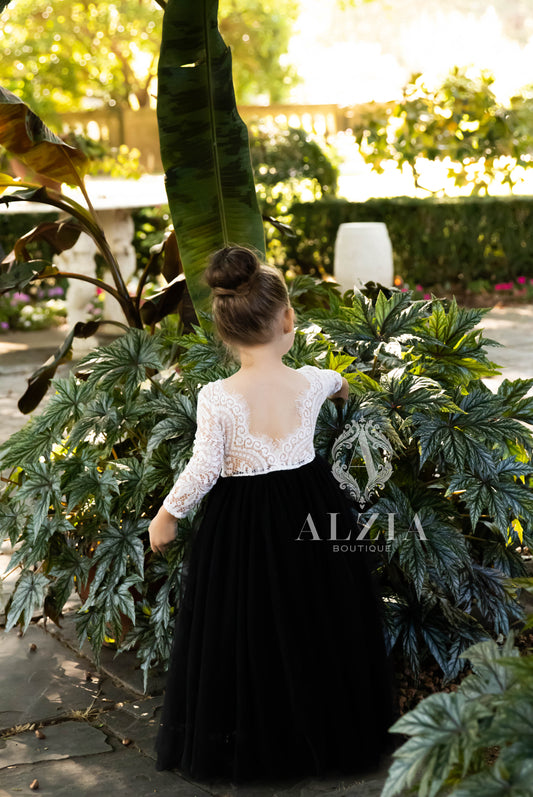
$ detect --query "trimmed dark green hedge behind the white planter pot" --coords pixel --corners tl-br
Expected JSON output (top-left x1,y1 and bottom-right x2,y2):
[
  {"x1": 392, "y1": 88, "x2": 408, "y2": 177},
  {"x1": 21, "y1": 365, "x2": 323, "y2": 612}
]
[{"x1": 282, "y1": 197, "x2": 533, "y2": 287}]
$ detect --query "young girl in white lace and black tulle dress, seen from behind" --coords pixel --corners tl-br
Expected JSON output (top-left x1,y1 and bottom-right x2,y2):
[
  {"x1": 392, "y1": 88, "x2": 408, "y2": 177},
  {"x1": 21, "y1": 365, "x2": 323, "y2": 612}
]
[{"x1": 150, "y1": 247, "x2": 393, "y2": 782}]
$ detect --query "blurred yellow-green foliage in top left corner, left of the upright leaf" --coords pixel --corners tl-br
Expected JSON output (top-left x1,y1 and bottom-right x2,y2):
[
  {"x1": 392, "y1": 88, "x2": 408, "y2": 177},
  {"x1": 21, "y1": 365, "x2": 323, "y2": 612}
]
[{"x1": 0, "y1": 0, "x2": 162, "y2": 114}]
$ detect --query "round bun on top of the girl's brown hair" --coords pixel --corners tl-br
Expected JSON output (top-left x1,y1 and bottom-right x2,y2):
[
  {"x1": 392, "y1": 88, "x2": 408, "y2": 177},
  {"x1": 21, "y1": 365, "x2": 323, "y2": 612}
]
[{"x1": 205, "y1": 246, "x2": 261, "y2": 296}]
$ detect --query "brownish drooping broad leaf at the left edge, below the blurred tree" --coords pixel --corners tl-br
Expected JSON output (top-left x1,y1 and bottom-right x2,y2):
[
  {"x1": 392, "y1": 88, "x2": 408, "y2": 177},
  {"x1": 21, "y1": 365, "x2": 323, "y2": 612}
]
[{"x1": 0, "y1": 86, "x2": 89, "y2": 185}]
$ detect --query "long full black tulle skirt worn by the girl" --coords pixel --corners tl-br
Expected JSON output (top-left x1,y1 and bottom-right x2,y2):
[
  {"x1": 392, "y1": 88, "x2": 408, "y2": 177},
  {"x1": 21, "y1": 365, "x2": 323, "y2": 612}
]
[{"x1": 156, "y1": 455, "x2": 393, "y2": 783}]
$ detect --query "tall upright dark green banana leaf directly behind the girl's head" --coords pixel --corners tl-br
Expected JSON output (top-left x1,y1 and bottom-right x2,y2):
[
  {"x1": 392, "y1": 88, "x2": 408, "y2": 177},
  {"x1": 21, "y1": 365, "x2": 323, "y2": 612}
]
[{"x1": 157, "y1": 0, "x2": 265, "y2": 318}]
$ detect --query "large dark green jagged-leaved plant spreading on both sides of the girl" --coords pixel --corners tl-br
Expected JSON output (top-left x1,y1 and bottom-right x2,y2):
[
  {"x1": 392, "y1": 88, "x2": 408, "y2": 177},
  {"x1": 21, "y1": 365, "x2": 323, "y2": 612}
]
[{"x1": 0, "y1": 282, "x2": 533, "y2": 688}]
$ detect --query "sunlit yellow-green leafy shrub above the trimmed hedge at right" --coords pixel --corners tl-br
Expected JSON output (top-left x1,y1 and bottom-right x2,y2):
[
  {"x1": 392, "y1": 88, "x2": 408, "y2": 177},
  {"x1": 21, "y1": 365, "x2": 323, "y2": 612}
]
[{"x1": 354, "y1": 67, "x2": 533, "y2": 194}]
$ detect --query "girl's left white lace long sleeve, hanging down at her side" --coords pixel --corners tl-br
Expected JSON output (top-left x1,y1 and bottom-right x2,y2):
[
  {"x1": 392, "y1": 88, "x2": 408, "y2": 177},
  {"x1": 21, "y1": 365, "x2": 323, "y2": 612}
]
[{"x1": 163, "y1": 384, "x2": 224, "y2": 518}]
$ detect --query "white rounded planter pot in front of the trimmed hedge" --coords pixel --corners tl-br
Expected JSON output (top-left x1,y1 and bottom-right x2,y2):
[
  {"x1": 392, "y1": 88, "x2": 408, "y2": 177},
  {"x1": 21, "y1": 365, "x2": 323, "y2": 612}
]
[{"x1": 333, "y1": 221, "x2": 394, "y2": 291}]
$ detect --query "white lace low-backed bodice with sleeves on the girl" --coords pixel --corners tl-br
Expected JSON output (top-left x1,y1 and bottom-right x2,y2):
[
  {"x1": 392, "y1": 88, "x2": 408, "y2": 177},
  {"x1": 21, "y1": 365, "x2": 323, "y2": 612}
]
[{"x1": 163, "y1": 365, "x2": 342, "y2": 518}]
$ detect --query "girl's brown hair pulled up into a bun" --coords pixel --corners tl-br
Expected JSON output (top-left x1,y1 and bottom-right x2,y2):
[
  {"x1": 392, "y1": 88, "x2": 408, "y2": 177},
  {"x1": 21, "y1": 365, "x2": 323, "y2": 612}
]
[{"x1": 205, "y1": 246, "x2": 290, "y2": 346}]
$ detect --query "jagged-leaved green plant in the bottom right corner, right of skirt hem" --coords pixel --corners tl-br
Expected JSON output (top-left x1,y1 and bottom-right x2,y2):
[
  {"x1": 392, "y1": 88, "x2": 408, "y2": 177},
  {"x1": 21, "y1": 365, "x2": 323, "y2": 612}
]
[{"x1": 382, "y1": 636, "x2": 533, "y2": 797}]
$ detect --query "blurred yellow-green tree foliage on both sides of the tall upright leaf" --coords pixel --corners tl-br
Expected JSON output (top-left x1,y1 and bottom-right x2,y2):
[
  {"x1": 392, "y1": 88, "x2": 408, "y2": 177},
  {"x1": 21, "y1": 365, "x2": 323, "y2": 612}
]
[{"x1": 0, "y1": 0, "x2": 298, "y2": 118}]
